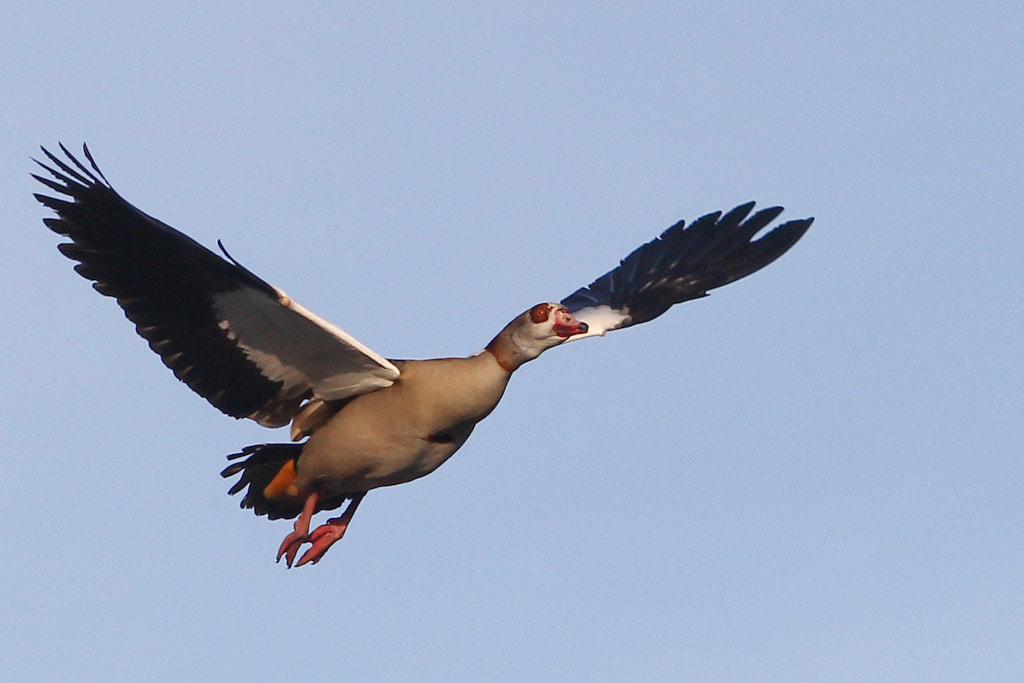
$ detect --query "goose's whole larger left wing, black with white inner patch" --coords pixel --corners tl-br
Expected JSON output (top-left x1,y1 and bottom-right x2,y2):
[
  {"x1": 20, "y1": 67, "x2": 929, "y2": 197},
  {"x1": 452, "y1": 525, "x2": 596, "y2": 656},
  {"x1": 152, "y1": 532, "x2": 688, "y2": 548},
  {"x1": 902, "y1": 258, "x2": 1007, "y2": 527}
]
[{"x1": 33, "y1": 144, "x2": 398, "y2": 427}]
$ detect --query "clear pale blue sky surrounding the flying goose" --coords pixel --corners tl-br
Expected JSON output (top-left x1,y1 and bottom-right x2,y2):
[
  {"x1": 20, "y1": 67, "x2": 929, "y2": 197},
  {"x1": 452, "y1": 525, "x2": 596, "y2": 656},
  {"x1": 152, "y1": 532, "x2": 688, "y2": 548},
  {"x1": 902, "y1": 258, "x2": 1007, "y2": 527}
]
[{"x1": 0, "y1": 2, "x2": 1024, "y2": 681}]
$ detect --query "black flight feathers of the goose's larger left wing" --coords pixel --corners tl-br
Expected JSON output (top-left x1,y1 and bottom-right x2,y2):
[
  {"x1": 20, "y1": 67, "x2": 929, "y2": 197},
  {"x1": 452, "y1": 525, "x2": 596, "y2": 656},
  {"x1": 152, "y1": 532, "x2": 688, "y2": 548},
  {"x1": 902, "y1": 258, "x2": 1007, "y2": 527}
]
[{"x1": 35, "y1": 145, "x2": 301, "y2": 418}]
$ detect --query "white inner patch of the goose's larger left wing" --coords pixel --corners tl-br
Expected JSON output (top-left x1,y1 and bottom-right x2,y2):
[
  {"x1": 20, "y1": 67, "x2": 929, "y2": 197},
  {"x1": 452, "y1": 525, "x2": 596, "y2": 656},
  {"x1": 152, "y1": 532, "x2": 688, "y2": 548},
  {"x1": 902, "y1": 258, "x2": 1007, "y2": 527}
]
[{"x1": 210, "y1": 288, "x2": 398, "y2": 400}]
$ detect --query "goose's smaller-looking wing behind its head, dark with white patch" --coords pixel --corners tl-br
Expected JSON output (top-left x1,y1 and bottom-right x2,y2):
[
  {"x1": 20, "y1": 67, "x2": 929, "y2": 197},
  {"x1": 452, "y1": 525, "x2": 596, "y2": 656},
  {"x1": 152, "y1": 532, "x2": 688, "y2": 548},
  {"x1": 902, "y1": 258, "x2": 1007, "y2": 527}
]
[{"x1": 562, "y1": 202, "x2": 814, "y2": 340}]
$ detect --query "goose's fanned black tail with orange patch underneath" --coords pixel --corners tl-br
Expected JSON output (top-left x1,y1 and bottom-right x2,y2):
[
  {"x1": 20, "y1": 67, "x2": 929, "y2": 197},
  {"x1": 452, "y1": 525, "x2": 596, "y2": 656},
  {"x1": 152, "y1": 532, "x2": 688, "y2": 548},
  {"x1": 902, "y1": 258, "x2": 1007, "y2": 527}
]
[{"x1": 220, "y1": 443, "x2": 304, "y2": 519}]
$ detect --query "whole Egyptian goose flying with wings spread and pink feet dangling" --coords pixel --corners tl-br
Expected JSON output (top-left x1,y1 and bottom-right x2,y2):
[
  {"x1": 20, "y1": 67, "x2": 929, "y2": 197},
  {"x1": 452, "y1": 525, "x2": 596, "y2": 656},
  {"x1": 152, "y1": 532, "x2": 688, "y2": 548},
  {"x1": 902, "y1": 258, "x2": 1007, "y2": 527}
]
[{"x1": 34, "y1": 144, "x2": 813, "y2": 566}]
